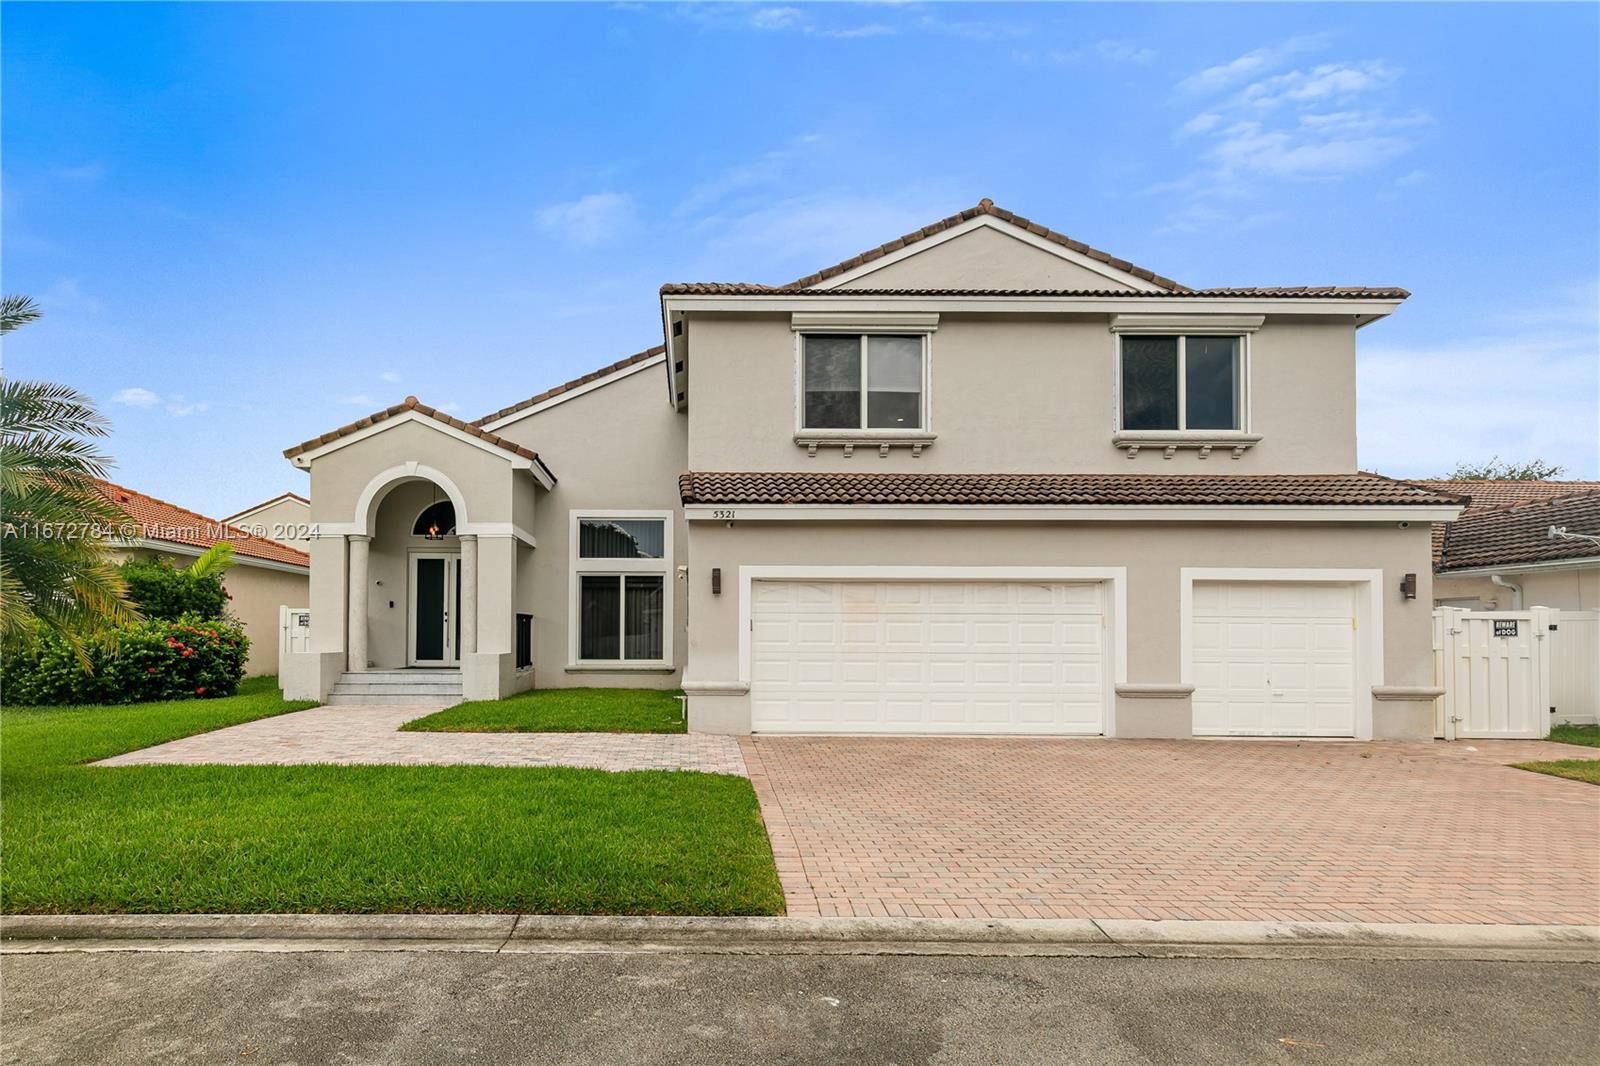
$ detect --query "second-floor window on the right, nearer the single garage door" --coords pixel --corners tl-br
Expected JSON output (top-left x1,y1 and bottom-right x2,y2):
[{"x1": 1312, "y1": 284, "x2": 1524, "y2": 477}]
[{"x1": 1122, "y1": 335, "x2": 1245, "y2": 432}]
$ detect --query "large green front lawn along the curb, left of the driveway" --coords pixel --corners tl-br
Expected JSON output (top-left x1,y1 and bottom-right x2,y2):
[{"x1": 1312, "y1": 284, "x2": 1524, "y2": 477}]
[{"x1": 0, "y1": 679, "x2": 782, "y2": 914}]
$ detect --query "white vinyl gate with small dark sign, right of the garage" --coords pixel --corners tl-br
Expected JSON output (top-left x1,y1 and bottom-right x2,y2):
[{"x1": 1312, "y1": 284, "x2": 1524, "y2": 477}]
[{"x1": 1434, "y1": 607, "x2": 1557, "y2": 739}]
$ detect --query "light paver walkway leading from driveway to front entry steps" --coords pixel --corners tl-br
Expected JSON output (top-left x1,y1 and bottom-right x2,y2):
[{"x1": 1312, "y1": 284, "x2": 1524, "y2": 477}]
[{"x1": 94, "y1": 706, "x2": 746, "y2": 776}]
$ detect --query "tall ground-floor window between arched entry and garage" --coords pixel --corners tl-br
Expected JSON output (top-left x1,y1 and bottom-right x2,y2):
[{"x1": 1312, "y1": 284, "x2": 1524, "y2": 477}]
[{"x1": 573, "y1": 515, "x2": 670, "y2": 663}]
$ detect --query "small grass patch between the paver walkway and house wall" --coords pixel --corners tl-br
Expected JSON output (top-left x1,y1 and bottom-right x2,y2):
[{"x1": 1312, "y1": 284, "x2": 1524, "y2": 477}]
[{"x1": 402, "y1": 688, "x2": 688, "y2": 733}]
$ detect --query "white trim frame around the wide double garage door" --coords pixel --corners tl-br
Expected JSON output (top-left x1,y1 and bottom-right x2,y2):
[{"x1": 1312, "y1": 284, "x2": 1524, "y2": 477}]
[{"x1": 739, "y1": 567, "x2": 1128, "y2": 736}]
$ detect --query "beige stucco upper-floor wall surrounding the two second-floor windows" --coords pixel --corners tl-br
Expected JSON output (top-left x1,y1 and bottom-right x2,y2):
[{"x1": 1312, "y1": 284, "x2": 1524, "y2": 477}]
[{"x1": 688, "y1": 314, "x2": 1355, "y2": 474}]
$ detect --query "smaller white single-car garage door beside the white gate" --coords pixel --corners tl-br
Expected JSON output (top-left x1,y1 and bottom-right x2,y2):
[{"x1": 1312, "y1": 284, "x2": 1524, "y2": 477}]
[{"x1": 1190, "y1": 581, "x2": 1357, "y2": 736}]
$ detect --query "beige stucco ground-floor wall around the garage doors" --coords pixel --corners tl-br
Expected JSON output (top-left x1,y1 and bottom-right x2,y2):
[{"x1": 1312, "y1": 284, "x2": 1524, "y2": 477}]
[{"x1": 685, "y1": 522, "x2": 1434, "y2": 719}]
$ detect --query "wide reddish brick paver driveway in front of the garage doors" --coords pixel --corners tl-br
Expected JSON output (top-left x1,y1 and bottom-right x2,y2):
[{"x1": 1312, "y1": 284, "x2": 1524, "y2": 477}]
[{"x1": 742, "y1": 738, "x2": 1600, "y2": 924}]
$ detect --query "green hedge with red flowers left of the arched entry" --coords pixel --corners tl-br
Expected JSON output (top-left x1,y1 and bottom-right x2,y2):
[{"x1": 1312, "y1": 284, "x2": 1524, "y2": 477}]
[{"x1": 0, "y1": 615, "x2": 250, "y2": 706}]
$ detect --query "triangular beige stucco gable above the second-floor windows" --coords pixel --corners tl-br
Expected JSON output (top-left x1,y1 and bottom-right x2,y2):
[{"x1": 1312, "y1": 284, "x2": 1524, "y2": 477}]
[{"x1": 838, "y1": 227, "x2": 1133, "y2": 290}]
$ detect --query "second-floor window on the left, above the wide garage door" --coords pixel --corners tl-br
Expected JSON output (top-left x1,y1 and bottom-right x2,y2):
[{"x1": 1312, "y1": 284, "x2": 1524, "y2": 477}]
[{"x1": 802, "y1": 333, "x2": 925, "y2": 429}]
